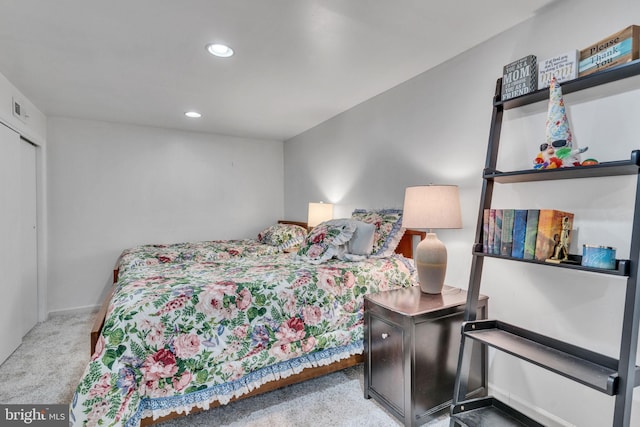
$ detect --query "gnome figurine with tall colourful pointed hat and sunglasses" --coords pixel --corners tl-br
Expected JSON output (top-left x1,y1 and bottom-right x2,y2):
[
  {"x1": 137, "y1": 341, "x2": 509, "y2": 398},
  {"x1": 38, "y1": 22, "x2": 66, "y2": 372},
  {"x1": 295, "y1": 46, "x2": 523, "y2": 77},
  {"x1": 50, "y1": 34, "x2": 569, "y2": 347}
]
[{"x1": 533, "y1": 76, "x2": 589, "y2": 169}]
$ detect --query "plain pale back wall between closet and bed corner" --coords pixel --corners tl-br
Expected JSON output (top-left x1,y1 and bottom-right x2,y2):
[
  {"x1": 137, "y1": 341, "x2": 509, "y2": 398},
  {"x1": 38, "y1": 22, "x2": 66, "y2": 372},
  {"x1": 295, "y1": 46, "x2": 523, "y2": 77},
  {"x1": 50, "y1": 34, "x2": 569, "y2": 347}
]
[{"x1": 47, "y1": 118, "x2": 284, "y2": 312}]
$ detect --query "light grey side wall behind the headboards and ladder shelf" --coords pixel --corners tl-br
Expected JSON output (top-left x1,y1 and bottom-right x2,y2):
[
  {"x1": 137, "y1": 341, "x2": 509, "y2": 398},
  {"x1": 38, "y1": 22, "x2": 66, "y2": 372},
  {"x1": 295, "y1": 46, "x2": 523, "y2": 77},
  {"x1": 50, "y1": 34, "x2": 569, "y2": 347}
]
[{"x1": 284, "y1": 0, "x2": 640, "y2": 427}]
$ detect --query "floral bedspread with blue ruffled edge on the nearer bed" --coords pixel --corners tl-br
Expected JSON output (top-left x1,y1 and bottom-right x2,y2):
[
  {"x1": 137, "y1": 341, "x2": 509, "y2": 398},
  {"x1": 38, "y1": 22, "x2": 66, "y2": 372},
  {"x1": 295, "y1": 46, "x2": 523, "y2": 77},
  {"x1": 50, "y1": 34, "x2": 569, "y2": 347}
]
[{"x1": 71, "y1": 254, "x2": 415, "y2": 426}]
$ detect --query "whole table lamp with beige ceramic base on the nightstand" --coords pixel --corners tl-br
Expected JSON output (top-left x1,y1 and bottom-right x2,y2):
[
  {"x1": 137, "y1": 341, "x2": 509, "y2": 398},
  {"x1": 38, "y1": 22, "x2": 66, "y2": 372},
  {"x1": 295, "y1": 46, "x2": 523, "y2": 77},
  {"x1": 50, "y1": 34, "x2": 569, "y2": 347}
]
[{"x1": 402, "y1": 185, "x2": 462, "y2": 294}]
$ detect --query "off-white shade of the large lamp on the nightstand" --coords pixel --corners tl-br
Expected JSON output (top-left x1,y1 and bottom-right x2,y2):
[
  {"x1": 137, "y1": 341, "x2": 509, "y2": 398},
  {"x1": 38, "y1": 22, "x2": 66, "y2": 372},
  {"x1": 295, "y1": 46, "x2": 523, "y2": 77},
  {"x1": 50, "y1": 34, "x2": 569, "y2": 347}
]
[{"x1": 402, "y1": 185, "x2": 462, "y2": 230}]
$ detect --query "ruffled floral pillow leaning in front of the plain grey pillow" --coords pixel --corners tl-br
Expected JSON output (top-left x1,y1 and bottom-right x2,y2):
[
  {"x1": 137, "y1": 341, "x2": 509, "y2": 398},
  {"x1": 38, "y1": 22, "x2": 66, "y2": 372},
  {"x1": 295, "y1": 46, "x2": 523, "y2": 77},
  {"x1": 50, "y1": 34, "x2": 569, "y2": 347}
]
[{"x1": 296, "y1": 219, "x2": 356, "y2": 264}]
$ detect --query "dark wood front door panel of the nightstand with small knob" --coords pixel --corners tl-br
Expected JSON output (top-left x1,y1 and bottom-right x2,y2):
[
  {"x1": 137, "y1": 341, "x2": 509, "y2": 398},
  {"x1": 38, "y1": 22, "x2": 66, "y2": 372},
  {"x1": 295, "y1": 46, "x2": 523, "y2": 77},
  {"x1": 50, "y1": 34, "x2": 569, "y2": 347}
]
[{"x1": 369, "y1": 316, "x2": 404, "y2": 415}]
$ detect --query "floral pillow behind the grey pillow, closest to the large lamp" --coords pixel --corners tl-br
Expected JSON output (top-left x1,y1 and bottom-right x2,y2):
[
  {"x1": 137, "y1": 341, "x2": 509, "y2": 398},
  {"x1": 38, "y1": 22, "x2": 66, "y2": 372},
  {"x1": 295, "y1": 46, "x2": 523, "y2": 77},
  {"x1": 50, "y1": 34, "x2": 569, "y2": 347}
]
[{"x1": 351, "y1": 209, "x2": 404, "y2": 257}]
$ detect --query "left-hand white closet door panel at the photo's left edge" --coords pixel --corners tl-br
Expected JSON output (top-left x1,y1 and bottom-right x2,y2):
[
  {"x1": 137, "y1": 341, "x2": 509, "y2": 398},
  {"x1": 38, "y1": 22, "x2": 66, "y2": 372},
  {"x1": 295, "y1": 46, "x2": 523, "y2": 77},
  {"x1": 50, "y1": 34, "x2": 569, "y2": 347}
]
[{"x1": 0, "y1": 124, "x2": 22, "y2": 363}]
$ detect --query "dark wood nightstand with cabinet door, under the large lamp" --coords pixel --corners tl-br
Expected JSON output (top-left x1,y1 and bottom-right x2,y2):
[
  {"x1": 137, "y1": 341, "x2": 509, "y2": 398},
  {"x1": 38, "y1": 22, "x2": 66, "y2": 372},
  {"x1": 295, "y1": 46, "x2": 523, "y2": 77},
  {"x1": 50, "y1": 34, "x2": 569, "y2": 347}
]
[{"x1": 364, "y1": 286, "x2": 488, "y2": 427}]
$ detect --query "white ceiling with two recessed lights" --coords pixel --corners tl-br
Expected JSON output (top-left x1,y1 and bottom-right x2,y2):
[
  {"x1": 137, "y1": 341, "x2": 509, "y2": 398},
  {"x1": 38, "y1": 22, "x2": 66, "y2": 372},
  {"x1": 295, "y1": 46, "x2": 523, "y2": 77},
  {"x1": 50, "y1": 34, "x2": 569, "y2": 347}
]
[{"x1": 0, "y1": 0, "x2": 550, "y2": 140}]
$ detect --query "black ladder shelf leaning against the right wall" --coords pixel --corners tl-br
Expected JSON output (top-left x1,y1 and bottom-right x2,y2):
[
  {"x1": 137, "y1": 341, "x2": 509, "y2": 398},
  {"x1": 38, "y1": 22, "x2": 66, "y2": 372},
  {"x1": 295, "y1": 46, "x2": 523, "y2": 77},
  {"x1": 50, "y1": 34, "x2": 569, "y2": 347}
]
[{"x1": 451, "y1": 60, "x2": 640, "y2": 427}]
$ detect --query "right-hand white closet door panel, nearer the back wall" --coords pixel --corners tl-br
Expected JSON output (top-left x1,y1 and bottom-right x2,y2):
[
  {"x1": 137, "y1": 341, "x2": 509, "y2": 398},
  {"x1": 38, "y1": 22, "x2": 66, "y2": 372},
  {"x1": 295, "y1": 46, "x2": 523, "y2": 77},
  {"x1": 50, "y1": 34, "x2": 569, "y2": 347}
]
[{"x1": 20, "y1": 140, "x2": 38, "y2": 335}]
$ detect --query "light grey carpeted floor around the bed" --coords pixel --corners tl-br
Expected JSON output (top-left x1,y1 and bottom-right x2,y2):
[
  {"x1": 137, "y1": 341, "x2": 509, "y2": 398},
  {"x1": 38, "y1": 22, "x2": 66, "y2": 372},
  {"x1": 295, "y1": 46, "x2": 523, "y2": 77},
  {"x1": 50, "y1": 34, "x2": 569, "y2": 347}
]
[{"x1": 0, "y1": 314, "x2": 449, "y2": 427}]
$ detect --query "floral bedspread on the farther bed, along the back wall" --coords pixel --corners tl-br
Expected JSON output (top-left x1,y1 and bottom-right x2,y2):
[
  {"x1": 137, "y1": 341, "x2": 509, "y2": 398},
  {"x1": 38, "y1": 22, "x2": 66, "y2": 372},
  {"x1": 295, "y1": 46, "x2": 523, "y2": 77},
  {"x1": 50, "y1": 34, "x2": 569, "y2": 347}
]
[{"x1": 117, "y1": 239, "x2": 281, "y2": 274}]
